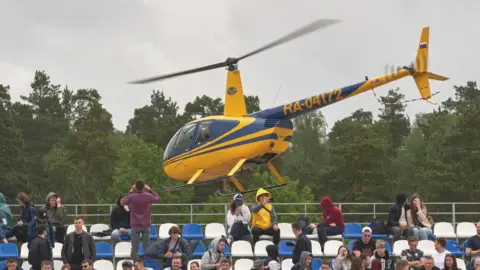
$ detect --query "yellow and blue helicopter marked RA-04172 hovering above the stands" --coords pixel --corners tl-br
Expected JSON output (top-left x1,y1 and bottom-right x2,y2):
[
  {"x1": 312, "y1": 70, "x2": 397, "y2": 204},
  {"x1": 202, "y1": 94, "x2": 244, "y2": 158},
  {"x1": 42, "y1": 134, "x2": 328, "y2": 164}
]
[{"x1": 131, "y1": 19, "x2": 448, "y2": 196}]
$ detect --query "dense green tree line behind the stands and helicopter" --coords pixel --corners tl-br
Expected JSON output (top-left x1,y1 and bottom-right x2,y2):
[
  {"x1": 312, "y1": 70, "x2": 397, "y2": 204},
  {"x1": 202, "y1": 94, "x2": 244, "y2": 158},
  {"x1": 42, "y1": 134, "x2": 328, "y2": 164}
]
[{"x1": 0, "y1": 71, "x2": 480, "y2": 210}]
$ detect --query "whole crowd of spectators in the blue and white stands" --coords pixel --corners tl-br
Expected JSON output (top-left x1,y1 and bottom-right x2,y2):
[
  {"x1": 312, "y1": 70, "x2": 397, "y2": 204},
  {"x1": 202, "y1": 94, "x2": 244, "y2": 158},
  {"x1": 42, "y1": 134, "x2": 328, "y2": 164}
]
[{"x1": 0, "y1": 186, "x2": 480, "y2": 270}]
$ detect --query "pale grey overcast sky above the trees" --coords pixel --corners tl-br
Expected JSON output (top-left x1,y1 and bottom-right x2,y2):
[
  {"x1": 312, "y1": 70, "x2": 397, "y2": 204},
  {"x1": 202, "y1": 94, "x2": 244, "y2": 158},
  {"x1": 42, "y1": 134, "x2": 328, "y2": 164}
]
[{"x1": 0, "y1": 0, "x2": 480, "y2": 130}]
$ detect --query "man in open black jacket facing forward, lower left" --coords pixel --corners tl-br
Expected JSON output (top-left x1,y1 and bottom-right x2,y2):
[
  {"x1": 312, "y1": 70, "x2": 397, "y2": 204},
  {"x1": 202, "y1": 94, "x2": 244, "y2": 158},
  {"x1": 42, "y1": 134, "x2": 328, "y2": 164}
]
[{"x1": 62, "y1": 217, "x2": 96, "y2": 270}]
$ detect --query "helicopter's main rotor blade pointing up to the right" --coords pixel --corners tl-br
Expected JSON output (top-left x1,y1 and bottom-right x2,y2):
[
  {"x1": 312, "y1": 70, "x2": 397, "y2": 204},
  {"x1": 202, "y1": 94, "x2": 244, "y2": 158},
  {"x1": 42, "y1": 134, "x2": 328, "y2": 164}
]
[{"x1": 236, "y1": 19, "x2": 341, "y2": 60}]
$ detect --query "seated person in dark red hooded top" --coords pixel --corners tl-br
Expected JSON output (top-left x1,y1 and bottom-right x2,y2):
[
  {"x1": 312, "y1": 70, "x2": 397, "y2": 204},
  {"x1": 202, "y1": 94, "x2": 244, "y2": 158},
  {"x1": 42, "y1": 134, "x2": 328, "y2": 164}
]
[{"x1": 310, "y1": 197, "x2": 345, "y2": 251}]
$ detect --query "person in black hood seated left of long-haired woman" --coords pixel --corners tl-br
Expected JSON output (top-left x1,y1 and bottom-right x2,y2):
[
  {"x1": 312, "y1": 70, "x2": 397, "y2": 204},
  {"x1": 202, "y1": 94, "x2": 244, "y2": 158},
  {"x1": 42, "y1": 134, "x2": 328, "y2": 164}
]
[{"x1": 387, "y1": 193, "x2": 411, "y2": 243}]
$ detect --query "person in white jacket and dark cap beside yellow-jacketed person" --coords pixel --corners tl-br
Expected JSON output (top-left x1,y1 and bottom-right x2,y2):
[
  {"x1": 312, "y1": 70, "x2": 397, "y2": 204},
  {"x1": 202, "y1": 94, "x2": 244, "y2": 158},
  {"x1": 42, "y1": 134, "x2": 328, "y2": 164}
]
[{"x1": 227, "y1": 194, "x2": 252, "y2": 241}]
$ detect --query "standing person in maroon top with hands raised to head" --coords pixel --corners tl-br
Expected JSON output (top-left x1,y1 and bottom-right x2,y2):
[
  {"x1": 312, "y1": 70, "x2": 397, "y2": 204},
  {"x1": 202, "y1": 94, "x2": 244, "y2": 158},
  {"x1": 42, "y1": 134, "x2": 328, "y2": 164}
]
[{"x1": 123, "y1": 180, "x2": 160, "y2": 260}]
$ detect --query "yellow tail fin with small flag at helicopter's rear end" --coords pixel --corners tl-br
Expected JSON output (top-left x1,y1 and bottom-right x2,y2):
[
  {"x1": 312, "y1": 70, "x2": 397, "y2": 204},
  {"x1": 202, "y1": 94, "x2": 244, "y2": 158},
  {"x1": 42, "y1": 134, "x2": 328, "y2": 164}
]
[{"x1": 413, "y1": 26, "x2": 448, "y2": 101}]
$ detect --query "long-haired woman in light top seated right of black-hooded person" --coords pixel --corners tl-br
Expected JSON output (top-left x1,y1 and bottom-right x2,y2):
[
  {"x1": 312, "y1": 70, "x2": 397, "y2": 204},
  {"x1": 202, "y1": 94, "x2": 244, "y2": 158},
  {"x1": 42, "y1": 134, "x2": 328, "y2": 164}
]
[{"x1": 407, "y1": 194, "x2": 433, "y2": 240}]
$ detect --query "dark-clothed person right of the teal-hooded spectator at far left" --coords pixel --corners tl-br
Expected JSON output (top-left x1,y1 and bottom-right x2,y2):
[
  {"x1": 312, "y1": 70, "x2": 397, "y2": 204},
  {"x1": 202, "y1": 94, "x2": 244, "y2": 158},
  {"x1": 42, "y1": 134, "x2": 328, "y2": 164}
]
[{"x1": 14, "y1": 192, "x2": 37, "y2": 246}]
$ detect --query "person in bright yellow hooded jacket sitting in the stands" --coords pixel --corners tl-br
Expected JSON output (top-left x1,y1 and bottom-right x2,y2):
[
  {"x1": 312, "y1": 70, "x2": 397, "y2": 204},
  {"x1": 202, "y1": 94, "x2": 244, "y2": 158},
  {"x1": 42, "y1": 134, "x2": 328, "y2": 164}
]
[{"x1": 252, "y1": 188, "x2": 280, "y2": 245}]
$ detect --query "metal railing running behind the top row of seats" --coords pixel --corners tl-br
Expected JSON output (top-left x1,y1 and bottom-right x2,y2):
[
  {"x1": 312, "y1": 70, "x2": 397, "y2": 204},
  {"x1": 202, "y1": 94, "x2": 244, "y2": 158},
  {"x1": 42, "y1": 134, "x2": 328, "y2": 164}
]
[{"x1": 10, "y1": 202, "x2": 480, "y2": 229}]
